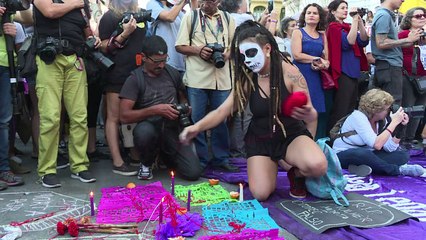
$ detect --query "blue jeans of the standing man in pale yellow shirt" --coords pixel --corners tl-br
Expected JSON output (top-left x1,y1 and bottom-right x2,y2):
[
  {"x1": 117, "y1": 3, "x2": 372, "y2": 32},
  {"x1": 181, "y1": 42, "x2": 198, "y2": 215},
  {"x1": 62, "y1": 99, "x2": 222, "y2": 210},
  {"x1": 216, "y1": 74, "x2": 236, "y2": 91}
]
[{"x1": 187, "y1": 87, "x2": 230, "y2": 167}]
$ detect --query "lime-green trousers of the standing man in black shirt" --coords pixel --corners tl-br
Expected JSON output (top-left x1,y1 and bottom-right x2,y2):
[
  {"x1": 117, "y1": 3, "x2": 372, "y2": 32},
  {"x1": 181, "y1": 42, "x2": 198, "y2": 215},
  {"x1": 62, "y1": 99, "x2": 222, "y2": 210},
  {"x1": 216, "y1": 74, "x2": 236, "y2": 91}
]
[{"x1": 36, "y1": 54, "x2": 89, "y2": 176}]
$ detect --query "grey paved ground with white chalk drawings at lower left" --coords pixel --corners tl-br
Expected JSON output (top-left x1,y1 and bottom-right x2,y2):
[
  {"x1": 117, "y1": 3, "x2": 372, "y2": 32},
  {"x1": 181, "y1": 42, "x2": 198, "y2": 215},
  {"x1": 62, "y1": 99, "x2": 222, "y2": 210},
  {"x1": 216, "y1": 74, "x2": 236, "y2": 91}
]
[{"x1": 0, "y1": 126, "x2": 297, "y2": 239}]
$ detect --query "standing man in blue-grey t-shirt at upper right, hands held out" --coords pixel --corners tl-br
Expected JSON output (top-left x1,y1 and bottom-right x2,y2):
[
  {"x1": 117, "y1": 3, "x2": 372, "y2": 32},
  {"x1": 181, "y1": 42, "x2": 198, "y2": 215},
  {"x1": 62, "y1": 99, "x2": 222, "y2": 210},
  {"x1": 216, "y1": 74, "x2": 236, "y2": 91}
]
[{"x1": 371, "y1": 0, "x2": 423, "y2": 104}]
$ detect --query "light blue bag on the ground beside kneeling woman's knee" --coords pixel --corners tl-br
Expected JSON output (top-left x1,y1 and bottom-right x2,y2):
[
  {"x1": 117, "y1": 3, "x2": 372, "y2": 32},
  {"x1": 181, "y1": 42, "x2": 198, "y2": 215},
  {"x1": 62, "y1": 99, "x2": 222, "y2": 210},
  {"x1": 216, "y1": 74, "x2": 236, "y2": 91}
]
[{"x1": 306, "y1": 138, "x2": 349, "y2": 207}]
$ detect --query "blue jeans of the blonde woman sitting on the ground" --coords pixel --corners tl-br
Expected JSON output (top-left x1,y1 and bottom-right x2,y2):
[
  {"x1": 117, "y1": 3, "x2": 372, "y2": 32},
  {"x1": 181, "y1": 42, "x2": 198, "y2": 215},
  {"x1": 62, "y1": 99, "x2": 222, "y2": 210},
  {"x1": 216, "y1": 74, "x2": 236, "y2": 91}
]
[{"x1": 337, "y1": 148, "x2": 410, "y2": 176}]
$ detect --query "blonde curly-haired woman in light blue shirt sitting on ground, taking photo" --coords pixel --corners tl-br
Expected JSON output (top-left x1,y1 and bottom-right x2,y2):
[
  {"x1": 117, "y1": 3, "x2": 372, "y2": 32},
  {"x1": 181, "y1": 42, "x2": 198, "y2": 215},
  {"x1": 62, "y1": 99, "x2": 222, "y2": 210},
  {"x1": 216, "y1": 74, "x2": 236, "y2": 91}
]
[{"x1": 333, "y1": 89, "x2": 424, "y2": 177}]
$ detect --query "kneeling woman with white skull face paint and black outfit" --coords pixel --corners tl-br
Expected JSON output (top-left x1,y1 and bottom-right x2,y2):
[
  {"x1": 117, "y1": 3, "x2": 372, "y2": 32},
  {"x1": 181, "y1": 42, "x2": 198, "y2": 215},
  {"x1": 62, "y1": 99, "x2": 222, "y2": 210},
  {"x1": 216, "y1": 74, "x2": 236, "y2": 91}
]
[{"x1": 180, "y1": 21, "x2": 327, "y2": 201}]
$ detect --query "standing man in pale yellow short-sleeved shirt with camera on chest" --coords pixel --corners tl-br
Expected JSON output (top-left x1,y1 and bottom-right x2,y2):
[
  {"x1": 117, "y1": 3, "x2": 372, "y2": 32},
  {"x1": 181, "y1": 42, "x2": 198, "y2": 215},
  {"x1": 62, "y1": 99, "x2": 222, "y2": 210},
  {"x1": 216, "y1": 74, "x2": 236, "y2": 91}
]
[{"x1": 175, "y1": 0, "x2": 238, "y2": 172}]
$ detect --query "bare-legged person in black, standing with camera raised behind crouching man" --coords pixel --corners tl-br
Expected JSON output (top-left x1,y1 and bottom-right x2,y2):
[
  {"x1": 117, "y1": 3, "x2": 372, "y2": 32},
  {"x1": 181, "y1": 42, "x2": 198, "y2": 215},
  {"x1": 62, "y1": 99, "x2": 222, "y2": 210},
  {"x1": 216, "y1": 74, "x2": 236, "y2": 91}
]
[{"x1": 99, "y1": 0, "x2": 151, "y2": 176}]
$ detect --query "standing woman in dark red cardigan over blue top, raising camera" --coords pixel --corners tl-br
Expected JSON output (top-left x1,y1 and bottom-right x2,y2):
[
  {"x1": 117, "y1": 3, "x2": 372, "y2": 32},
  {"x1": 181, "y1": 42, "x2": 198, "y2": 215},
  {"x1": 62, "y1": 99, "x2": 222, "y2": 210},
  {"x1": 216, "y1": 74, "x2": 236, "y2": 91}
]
[{"x1": 327, "y1": 0, "x2": 369, "y2": 130}]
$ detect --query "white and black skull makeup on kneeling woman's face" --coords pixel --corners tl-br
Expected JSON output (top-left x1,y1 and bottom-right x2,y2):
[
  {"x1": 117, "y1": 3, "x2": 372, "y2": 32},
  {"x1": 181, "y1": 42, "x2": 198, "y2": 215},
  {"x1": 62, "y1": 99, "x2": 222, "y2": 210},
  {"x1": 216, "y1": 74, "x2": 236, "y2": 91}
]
[{"x1": 239, "y1": 42, "x2": 265, "y2": 73}]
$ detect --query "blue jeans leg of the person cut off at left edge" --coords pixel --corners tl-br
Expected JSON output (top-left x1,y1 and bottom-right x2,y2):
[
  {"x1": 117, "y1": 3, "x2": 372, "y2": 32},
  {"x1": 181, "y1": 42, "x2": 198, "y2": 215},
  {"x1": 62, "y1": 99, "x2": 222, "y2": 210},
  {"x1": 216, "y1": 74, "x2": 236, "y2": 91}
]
[{"x1": 0, "y1": 66, "x2": 12, "y2": 172}]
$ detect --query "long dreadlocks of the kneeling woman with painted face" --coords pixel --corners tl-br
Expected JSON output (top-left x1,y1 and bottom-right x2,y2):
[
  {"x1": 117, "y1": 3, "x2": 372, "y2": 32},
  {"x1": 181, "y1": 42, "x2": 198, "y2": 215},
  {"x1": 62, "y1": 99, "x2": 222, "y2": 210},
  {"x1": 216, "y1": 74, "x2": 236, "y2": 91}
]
[{"x1": 231, "y1": 20, "x2": 293, "y2": 135}]
